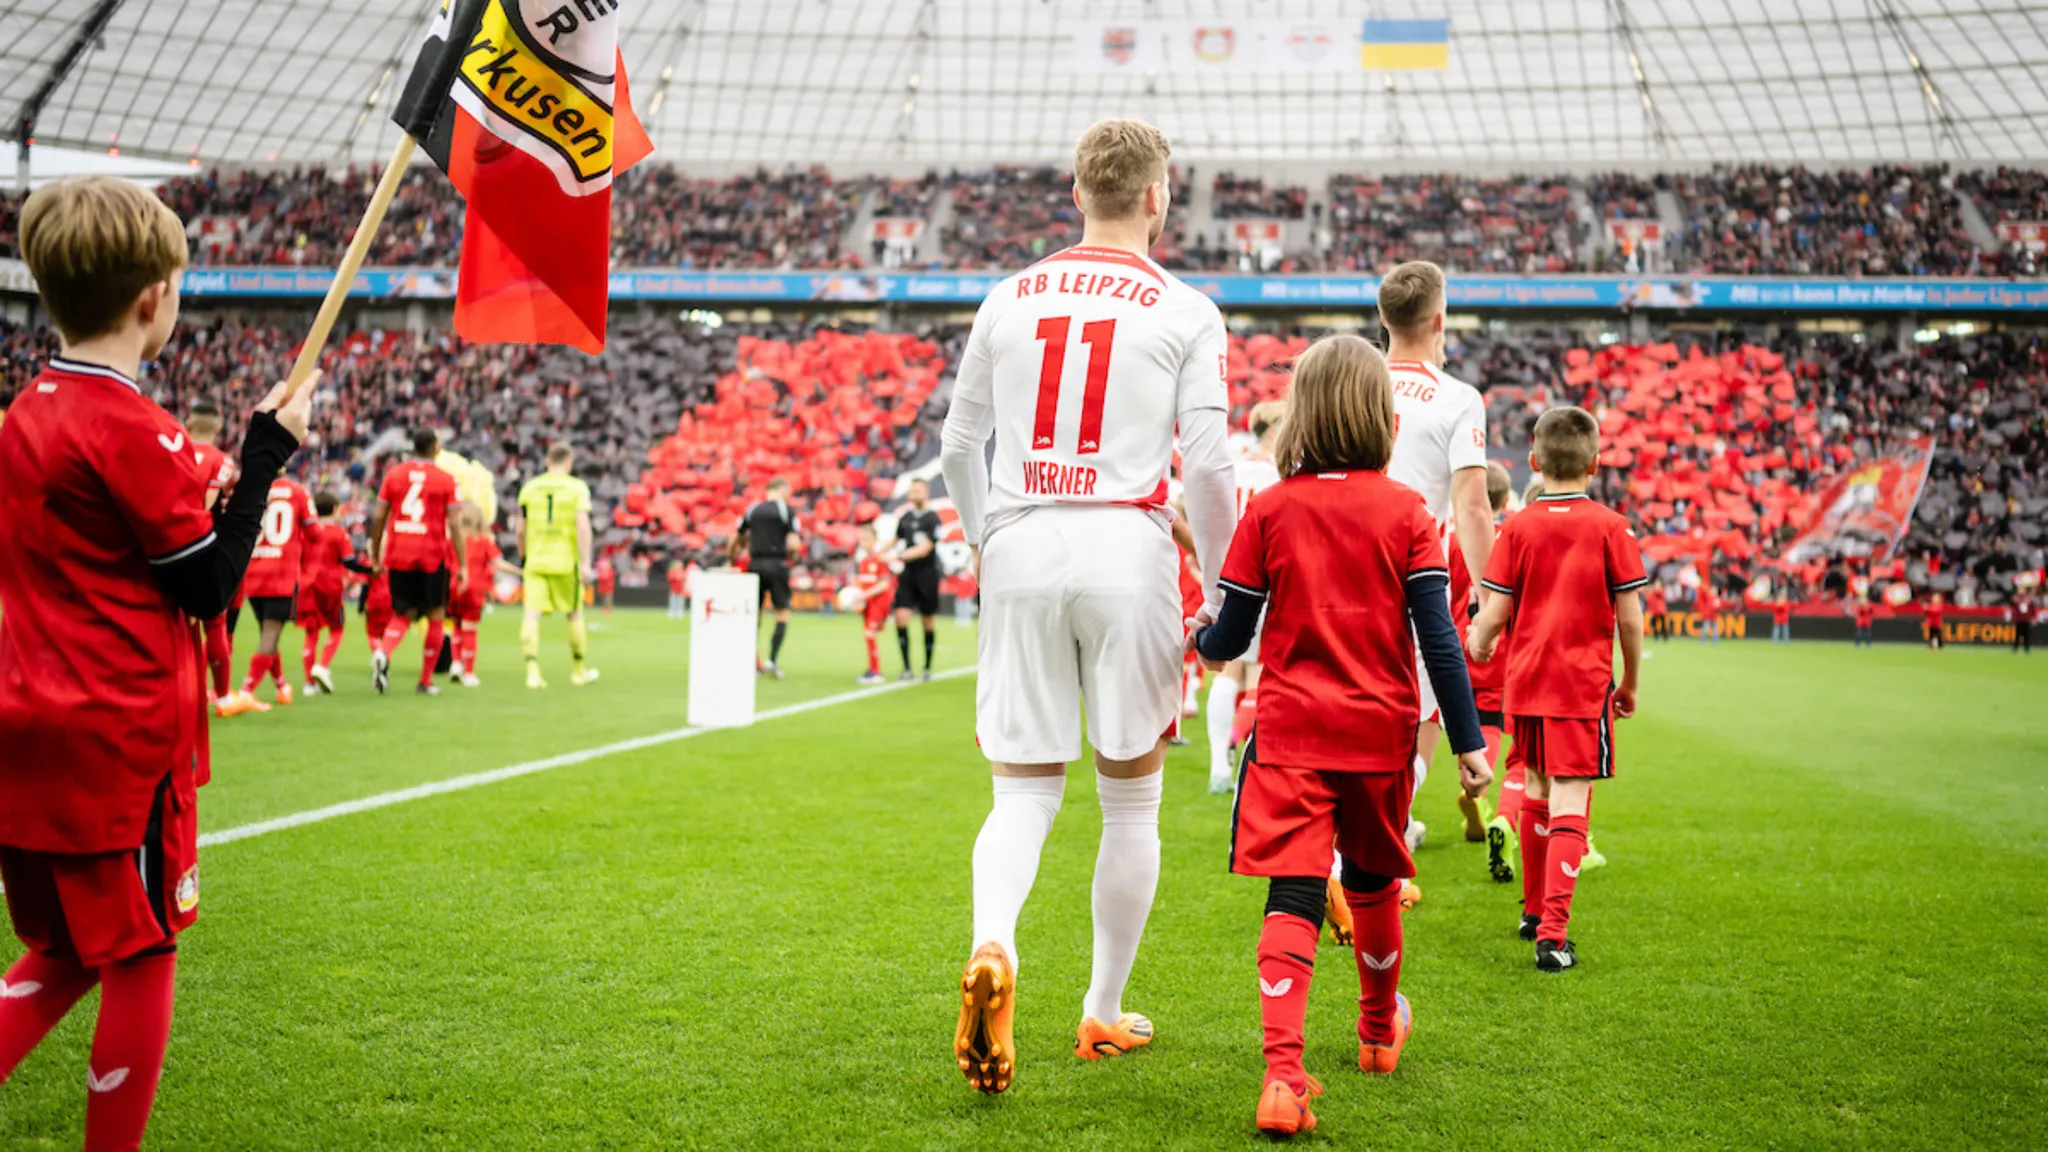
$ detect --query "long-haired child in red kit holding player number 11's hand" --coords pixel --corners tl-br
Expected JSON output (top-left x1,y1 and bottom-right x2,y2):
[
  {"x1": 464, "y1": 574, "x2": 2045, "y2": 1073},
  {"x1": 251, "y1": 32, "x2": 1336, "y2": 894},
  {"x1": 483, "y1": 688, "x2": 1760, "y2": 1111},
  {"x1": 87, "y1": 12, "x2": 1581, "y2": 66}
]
[{"x1": 1190, "y1": 336, "x2": 1493, "y2": 1136}]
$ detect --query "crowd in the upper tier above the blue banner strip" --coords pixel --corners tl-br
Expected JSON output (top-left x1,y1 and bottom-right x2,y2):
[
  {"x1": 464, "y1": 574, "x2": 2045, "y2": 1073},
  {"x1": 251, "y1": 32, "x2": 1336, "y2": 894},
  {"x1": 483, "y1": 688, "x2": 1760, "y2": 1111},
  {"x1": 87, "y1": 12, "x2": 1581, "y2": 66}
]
[{"x1": 12, "y1": 162, "x2": 2048, "y2": 277}]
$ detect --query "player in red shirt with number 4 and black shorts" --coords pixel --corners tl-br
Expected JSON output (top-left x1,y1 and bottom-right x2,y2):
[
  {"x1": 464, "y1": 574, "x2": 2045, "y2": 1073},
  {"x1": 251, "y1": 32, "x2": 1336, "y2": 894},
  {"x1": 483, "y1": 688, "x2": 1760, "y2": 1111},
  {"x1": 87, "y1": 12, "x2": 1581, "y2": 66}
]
[{"x1": 371, "y1": 428, "x2": 469, "y2": 697}]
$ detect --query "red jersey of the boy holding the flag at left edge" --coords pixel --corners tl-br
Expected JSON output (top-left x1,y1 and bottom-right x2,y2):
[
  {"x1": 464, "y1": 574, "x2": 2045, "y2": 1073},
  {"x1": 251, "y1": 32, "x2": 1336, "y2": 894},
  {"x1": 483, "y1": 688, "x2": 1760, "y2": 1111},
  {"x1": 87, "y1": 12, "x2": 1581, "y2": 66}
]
[{"x1": 0, "y1": 359, "x2": 213, "y2": 853}]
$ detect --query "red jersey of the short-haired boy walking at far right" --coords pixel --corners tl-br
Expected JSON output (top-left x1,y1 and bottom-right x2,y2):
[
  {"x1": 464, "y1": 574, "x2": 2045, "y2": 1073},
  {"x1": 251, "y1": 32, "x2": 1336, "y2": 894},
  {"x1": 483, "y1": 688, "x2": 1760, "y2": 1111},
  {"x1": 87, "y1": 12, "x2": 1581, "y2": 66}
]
[{"x1": 1483, "y1": 492, "x2": 1651, "y2": 719}]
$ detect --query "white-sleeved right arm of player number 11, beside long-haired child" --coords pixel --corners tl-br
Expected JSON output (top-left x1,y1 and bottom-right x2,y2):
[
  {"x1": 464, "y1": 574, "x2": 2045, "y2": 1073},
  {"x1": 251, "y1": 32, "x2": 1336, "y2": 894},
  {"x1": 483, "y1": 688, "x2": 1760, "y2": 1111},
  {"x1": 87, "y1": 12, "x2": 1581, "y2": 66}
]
[{"x1": 1176, "y1": 299, "x2": 1237, "y2": 613}]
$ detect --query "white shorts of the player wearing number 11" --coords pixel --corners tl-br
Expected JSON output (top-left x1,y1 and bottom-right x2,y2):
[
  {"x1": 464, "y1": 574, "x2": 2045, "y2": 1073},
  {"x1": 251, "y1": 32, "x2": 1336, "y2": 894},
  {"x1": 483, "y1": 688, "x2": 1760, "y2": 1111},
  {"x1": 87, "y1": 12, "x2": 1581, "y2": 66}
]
[{"x1": 975, "y1": 506, "x2": 1184, "y2": 765}]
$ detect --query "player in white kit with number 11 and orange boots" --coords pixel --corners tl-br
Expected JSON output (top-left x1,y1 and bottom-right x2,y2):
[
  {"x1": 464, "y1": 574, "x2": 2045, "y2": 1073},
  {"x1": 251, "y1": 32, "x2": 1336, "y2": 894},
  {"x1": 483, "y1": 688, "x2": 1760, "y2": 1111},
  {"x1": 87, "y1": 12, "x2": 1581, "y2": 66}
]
[{"x1": 940, "y1": 121, "x2": 1237, "y2": 1093}]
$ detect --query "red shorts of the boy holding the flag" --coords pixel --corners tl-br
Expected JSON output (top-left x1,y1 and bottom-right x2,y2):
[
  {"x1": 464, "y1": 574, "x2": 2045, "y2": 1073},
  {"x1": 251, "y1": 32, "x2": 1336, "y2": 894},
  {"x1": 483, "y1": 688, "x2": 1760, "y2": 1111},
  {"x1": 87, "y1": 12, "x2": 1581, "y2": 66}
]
[{"x1": 0, "y1": 774, "x2": 199, "y2": 968}]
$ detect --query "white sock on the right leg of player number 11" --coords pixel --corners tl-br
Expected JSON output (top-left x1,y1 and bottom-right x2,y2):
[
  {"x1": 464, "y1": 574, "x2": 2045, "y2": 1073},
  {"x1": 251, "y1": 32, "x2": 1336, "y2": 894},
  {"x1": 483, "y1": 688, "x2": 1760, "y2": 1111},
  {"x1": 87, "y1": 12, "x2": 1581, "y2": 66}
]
[{"x1": 1081, "y1": 773, "x2": 1165, "y2": 1025}]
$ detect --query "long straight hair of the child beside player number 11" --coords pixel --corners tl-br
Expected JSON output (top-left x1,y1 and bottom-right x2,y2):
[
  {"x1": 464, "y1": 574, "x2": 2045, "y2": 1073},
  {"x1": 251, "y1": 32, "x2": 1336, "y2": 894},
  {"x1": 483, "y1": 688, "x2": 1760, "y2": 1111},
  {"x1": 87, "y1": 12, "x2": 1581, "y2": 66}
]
[{"x1": 1274, "y1": 336, "x2": 1395, "y2": 476}]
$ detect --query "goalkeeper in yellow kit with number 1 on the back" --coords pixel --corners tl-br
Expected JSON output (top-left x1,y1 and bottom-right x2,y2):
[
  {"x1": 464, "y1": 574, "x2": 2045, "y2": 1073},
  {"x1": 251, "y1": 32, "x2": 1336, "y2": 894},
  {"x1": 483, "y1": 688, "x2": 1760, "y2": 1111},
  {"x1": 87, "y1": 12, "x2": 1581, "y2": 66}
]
[{"x1": 518, "y1": 445, "x2": 598, "y2": 689}]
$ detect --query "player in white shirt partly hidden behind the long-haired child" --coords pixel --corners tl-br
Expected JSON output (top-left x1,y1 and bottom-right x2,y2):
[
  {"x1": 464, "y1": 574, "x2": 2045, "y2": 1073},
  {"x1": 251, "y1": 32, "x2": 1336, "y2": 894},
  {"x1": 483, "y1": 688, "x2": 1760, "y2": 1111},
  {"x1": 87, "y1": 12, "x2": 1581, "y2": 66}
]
[{"x1": 1380, "y1": 260, "x2": 1493, "y2": 869}]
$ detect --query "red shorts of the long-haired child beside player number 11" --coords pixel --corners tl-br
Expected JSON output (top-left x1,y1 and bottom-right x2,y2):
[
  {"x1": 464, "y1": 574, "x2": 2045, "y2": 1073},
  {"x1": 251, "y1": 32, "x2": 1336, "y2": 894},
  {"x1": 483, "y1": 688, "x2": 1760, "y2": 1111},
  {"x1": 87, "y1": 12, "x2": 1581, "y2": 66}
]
[{"x1": 1231, "y1": 732, "x2": 1415, "y2": 877}]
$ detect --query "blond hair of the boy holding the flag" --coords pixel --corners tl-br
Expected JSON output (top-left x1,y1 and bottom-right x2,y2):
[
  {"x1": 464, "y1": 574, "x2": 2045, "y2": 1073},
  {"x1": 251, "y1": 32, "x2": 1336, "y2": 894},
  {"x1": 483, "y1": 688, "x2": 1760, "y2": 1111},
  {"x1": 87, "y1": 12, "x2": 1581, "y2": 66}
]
[{"x1": 20, "y1": 176, "x2": 184, "y2": 342}]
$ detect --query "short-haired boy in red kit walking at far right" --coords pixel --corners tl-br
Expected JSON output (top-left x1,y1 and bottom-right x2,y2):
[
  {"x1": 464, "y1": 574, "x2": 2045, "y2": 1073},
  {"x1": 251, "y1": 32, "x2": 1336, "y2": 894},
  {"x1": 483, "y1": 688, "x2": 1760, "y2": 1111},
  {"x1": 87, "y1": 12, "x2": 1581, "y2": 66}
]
[{"x1": 1470, "y1": 408, "x2": 1646, "y2": 972}]
